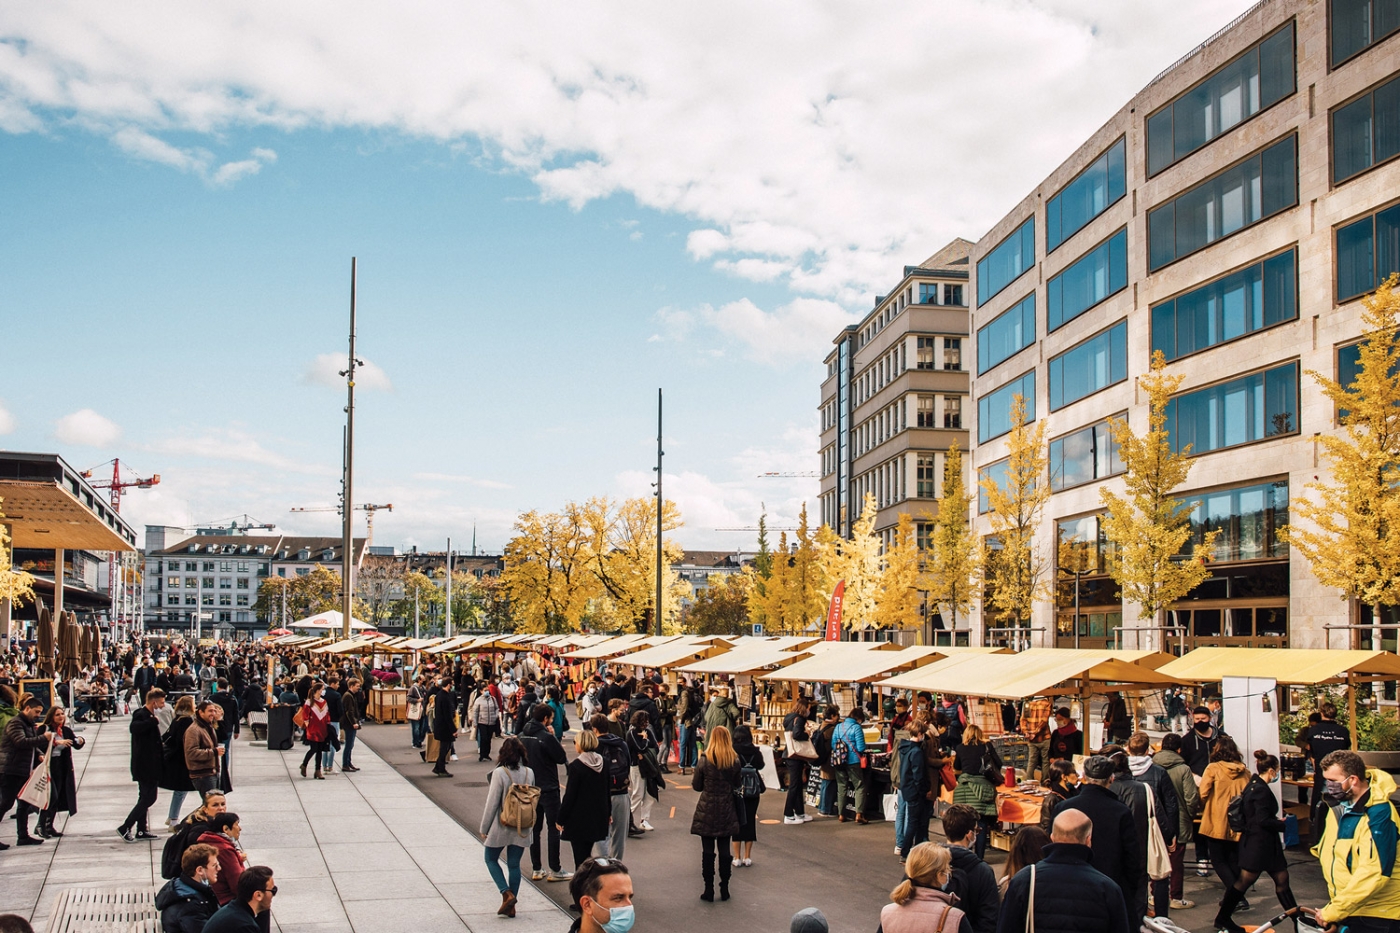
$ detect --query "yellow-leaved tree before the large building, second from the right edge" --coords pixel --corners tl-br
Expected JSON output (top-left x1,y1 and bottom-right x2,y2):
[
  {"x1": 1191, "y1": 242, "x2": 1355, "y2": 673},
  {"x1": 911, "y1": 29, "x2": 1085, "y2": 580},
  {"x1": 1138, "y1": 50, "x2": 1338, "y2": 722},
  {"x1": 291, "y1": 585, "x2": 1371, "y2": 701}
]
[{"x1": 1103, "y1": 350, "x2": 1219, "y2": 636}]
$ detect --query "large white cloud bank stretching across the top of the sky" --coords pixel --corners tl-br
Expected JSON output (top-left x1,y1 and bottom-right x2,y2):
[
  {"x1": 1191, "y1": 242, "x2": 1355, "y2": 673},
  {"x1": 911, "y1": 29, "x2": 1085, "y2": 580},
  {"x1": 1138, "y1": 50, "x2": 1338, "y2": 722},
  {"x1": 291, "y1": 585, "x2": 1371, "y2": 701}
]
[{"x1": 0, "y1": 0, "x2": 1253, "y2": 307}]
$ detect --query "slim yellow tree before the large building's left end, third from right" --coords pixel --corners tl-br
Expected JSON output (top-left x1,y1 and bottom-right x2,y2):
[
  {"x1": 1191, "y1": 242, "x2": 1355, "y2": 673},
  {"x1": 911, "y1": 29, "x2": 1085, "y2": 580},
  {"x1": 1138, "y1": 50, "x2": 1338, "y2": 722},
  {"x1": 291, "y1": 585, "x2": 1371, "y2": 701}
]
[{"x1": 980, "y1": 394, "x2": 1050, "y2": 638}]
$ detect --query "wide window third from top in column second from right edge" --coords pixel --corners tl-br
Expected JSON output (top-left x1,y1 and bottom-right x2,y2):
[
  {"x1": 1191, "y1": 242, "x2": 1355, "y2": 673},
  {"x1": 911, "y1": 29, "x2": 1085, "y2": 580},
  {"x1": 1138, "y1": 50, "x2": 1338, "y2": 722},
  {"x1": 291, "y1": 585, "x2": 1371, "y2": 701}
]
[{"x1": 1152, "y1": 249, "x2": 1298, "y2": 360}]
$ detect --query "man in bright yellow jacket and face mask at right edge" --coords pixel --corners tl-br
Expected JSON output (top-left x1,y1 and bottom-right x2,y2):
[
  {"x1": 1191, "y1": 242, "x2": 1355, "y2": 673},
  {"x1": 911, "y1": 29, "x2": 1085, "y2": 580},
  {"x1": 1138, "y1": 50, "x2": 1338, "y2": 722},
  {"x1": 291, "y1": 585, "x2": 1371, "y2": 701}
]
[{"x1": 1312, "y1": 751, "x2": 1400, "y2": 933}]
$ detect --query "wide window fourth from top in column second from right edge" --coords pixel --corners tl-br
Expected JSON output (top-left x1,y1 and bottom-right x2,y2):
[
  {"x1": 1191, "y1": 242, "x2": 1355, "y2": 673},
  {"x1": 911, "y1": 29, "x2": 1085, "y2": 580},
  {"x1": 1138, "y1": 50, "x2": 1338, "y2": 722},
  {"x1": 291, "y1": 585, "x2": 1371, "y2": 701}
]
[{"x1": 1166, "y1": 363, "x2": 1298, "y2": 454}]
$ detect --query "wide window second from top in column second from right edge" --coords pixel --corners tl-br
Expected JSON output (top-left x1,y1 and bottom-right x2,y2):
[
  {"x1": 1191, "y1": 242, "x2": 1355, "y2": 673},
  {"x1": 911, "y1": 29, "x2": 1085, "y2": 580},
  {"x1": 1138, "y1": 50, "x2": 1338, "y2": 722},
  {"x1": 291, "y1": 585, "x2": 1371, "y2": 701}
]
[{"x1": 1147, "y1": 136, "x2": 1298, "y2": 272}]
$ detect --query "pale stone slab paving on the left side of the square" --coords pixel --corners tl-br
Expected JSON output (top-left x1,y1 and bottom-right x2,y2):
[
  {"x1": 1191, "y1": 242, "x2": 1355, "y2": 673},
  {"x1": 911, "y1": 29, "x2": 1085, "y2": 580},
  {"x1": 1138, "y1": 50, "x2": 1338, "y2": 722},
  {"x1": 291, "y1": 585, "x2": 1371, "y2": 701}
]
[{"x1": 0, "y1": 717, "x2": 571, "y2": 933}]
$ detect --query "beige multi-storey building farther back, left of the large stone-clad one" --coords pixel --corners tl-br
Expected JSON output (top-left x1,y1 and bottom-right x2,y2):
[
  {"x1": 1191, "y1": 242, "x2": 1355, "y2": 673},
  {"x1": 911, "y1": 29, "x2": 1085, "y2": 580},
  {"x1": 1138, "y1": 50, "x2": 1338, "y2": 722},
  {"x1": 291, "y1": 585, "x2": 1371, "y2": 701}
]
[{"x1": 820, "y1": 240, "x2": 972, "y2": 636}]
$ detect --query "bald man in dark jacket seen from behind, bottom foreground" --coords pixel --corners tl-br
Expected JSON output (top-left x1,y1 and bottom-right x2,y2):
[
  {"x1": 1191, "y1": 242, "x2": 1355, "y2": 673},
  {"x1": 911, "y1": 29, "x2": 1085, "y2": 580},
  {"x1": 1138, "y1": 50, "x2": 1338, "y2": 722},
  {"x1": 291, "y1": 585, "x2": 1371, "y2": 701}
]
[{"x1": 1002, "y1": 808, "x2": 1130, "y2": 933}]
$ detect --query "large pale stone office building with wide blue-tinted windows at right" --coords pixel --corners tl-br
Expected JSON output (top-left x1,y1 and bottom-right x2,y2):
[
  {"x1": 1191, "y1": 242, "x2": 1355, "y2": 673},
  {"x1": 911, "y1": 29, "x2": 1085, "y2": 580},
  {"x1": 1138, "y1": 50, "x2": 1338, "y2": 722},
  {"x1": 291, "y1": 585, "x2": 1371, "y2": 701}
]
[{"x1": 969, "y1": 0, "x2": 1400, "y2": 649}]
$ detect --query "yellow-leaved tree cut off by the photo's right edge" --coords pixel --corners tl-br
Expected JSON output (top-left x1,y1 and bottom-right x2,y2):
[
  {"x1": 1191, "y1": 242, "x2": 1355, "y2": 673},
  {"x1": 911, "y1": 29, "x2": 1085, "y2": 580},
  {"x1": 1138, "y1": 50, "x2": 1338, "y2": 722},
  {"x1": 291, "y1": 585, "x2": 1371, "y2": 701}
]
[{"x1": 1285, "y1": 276, "x2": 1400, "y2": 633}]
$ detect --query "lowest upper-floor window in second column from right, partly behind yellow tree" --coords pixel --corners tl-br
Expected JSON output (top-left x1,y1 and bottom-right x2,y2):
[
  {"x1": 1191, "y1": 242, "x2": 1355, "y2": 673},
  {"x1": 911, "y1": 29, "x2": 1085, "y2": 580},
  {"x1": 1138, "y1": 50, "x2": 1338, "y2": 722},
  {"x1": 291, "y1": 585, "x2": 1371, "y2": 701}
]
[{"x1": 1183, "y1": 479, "x2": 1288, "y2": 562}]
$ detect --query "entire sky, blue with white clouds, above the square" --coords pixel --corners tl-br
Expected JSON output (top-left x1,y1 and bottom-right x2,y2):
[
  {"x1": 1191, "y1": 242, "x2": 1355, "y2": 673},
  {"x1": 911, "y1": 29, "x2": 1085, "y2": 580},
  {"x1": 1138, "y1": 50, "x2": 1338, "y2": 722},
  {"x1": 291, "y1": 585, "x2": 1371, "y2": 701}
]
[{"x1": 0, "y1": 0, "x2": 1246, "y2": 548}]
